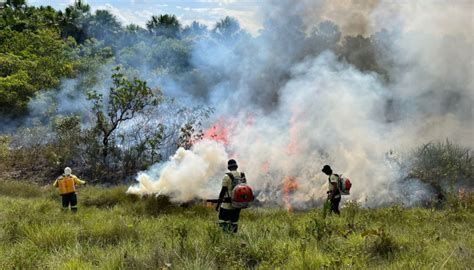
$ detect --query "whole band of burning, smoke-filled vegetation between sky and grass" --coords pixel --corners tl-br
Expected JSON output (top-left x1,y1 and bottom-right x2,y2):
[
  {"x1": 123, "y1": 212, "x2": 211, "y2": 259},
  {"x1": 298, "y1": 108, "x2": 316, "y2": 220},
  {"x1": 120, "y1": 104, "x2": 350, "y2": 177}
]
[{"x1": 0, "y1": 1, "x2": 474, "y2": 209}]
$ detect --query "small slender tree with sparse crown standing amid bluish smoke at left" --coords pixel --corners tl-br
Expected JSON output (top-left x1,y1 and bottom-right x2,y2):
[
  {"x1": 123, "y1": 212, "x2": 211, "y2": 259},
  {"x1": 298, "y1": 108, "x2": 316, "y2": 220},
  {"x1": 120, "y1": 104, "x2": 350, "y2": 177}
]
[{"x1": 88, "y1": 67, "x2": 161, "y2": 165}]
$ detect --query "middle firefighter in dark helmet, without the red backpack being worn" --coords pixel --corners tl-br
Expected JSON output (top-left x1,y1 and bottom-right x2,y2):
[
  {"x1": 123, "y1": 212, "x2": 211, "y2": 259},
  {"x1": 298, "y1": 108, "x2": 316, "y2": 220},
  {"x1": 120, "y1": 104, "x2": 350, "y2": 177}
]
[{"x1": 216, "y1": 159, "x2": 246, "y2": 233}]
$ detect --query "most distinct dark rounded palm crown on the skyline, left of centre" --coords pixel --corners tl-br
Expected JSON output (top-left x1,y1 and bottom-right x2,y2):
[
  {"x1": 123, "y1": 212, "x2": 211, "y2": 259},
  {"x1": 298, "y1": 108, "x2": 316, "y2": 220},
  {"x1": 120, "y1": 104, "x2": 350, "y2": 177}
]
[{"x1": 146, "y1": 14, "x2": 181, "y2": 38}]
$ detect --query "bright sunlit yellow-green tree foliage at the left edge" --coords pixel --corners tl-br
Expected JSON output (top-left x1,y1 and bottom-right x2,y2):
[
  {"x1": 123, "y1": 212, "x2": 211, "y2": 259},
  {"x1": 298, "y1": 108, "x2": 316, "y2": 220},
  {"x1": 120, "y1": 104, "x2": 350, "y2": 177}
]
[{"x1": 0, "y1": 29, "x2": 74, "y2": 115}]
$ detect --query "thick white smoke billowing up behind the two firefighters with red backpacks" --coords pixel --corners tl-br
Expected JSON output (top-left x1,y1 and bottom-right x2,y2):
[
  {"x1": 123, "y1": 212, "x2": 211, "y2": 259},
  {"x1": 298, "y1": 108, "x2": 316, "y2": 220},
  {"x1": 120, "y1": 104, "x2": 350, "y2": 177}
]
[{"x1": 131, "y1": 1, "x2": 474, "y2": 207}]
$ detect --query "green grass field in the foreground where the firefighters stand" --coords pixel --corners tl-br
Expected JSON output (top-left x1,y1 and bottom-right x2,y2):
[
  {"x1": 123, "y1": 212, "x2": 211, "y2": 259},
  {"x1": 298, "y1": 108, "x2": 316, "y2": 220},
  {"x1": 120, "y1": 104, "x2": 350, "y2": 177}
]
[{"x1": 0, "y1": 182, "x2": 474, "y2": 269}]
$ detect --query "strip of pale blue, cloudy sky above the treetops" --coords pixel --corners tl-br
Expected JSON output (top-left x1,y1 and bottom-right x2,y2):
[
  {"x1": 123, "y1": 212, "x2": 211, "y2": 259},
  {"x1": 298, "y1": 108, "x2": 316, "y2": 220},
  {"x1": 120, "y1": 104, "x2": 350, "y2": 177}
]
[{"x1": 28, "y1": 0, "x2": 263, "y2": 34}]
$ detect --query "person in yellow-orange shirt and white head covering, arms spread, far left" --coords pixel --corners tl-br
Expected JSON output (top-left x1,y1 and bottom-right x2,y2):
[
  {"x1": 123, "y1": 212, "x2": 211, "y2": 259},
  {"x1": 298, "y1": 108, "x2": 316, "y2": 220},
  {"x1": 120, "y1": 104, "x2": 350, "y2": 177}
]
[{"x1": 53, "y1": 167, "x2": 86, "y2": 213}]
